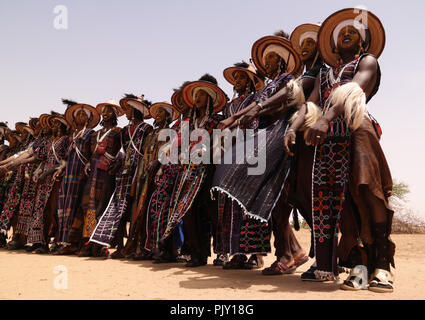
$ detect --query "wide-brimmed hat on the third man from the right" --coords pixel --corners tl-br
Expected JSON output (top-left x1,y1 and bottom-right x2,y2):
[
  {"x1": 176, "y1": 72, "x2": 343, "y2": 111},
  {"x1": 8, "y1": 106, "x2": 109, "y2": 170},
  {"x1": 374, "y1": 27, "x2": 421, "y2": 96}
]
[{"x1": 251, "y1": 36, "x2": 301, "y2": 75}]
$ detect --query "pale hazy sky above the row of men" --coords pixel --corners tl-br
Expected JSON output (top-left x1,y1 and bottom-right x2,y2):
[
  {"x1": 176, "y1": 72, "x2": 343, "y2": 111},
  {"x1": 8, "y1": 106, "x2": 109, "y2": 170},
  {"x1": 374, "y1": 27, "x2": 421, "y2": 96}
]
[{"x1": 0, "y1": 0, "x2": 425, "y2": 217}]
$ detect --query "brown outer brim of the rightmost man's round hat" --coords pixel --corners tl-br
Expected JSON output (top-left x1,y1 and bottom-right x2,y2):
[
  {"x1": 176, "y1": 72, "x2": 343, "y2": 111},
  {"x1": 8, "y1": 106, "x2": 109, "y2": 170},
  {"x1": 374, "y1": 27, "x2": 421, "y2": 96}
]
[{"x1": 317, "y1": 8, "x2": 385, "y2": 67}]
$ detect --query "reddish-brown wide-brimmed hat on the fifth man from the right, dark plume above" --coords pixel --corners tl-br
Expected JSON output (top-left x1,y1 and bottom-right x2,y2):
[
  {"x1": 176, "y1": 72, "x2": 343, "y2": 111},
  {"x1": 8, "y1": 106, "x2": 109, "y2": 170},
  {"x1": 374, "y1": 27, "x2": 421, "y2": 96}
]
[{"x1": 182, "y1": 81, "x2": 227, "y2": 112}]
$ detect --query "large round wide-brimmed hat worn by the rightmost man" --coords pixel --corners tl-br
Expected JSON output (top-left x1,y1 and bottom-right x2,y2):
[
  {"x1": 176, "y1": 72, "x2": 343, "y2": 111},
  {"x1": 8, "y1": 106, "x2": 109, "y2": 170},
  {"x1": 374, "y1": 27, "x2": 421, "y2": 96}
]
[{"x1": 318, "y1": 8, "x2": 385, "y2": 67}]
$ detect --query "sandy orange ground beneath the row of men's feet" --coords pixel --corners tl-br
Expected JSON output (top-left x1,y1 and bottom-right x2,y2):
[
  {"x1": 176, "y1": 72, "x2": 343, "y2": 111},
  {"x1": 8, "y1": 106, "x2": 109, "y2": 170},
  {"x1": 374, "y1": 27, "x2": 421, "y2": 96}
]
[{"x1": 0, "y1": 230, "x2": 425, "y2": 300}]
